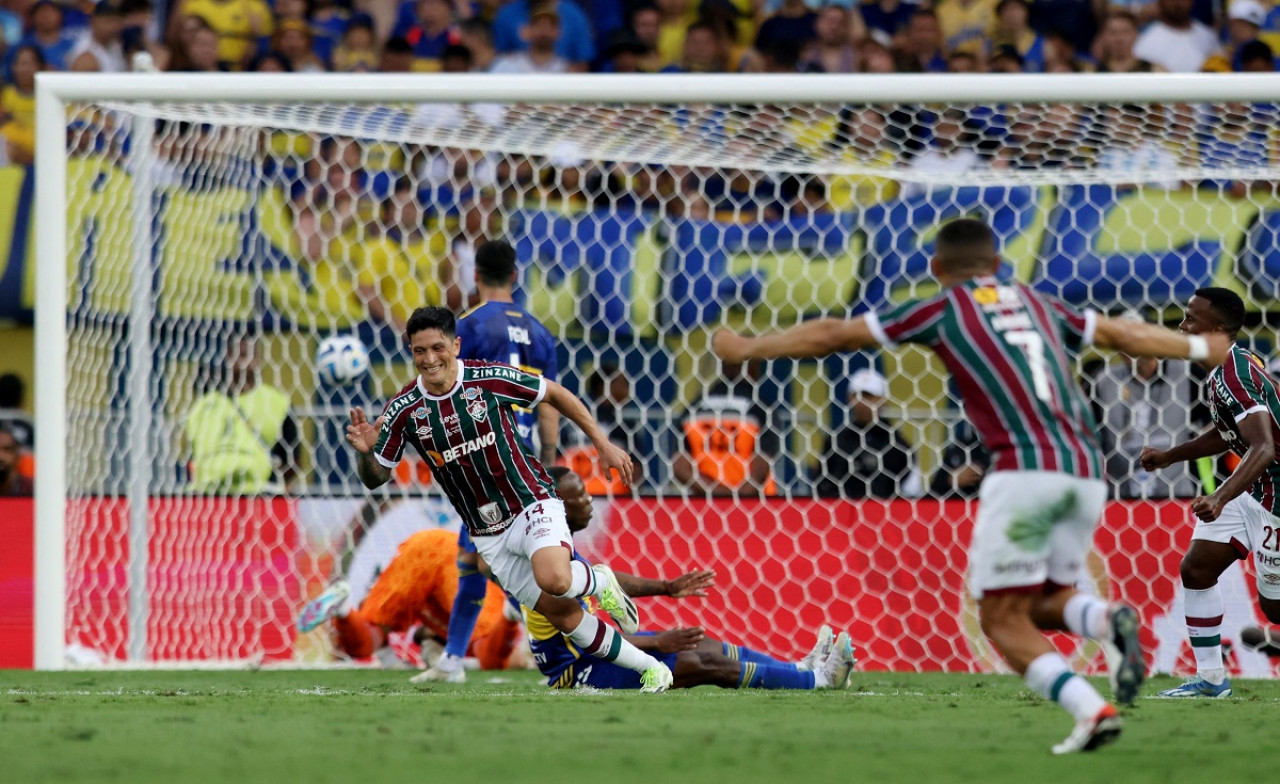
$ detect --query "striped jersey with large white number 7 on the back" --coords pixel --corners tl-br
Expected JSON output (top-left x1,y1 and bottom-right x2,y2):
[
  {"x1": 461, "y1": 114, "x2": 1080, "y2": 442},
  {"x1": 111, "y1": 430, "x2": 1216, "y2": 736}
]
[{"x1": 867, "y1": 278, "x2": 1102, "y2": 478}]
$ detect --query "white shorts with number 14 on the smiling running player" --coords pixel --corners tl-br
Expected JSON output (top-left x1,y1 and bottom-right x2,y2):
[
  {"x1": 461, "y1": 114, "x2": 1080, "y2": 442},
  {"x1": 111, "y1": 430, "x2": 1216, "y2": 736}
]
[{"x1": 471, "y1": 498, "x2": 573, "y2": 607}]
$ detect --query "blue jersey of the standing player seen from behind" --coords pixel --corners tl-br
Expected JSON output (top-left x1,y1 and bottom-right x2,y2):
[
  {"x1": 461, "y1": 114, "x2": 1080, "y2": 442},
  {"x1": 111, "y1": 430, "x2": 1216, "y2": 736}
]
[{"x1": 458, "y1": 302, "x2": 559, "y2": 448}]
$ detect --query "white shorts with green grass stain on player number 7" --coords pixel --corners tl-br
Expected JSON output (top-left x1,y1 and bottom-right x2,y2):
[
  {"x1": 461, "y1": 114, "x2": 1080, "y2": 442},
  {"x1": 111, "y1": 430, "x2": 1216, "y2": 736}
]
[{"x1": 969, "y1": 471, "x2": 1107, "y2": 598}]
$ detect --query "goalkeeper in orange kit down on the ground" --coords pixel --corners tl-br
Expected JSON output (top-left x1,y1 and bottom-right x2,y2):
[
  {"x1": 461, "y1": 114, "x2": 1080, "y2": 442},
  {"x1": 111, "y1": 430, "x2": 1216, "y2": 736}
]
[{"x1": 298, "y1": 502, "x2": 532, "y2": 670}]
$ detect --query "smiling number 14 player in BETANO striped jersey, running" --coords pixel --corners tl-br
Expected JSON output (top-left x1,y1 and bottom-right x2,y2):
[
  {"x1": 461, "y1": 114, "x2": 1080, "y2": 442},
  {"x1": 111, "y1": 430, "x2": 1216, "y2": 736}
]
[{"x1": 347, "y1": 307, "x2": 672, "y2": 692}]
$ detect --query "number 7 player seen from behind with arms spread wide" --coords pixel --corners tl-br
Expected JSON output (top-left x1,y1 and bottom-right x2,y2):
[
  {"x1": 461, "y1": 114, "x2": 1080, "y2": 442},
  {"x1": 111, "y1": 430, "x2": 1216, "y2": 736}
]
[{"x1": 712, "y1": 219, "x2": 1229, "y2": 753}]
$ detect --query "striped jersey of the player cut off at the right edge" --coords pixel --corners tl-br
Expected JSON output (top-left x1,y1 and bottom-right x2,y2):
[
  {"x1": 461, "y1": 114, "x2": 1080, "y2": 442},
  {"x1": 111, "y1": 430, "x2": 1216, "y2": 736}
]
[{"x1": 1206, "y1": 343, "x2": 1280, "y2": 515}]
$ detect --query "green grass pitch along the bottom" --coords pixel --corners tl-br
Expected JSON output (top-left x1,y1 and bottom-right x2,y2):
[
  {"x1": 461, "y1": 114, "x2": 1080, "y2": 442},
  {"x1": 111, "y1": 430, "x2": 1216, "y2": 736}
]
[{"x1": 0, "y1": 670, "x2": 1280, "y2": 784}]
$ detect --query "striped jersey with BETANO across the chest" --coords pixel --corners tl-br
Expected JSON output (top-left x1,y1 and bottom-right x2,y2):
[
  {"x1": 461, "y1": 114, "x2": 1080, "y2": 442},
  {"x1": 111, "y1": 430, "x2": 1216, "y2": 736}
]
[{"x1": 374, "y1": 360, "x2": 556, "y2": 537}]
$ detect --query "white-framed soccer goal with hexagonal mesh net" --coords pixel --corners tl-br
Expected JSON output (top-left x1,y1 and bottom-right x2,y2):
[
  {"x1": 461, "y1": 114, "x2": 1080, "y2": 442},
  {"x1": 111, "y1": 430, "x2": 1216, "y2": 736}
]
[{"x1": 37, "y1": 76, "x2": 1280, "y2": 675}]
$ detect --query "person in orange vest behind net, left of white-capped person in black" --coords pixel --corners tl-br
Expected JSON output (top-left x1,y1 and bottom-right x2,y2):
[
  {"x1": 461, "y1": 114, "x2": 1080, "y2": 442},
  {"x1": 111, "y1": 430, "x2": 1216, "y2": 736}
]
[{"x1": 671, "y1": 361, "x2": 780, "y2": 497}]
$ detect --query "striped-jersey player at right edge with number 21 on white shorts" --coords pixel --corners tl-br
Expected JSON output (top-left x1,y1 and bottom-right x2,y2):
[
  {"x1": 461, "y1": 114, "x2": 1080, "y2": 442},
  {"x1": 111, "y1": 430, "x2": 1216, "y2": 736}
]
[{"x1": 1139, "y1": 288, "x2": 1280, "y2": 697}]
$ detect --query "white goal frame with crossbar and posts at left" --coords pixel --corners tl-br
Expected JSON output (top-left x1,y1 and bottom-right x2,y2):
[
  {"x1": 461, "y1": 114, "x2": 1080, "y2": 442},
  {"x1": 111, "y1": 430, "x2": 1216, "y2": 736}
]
[{"x1": 35, "y1": 73, "x2": 1280, "y2": 670}]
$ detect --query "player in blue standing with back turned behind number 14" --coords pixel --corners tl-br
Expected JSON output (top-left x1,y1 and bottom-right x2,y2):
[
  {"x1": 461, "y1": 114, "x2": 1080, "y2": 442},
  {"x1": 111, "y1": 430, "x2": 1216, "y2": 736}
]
[{"x1": 422, "y1": 240, "x2": 559, "y2": 683}]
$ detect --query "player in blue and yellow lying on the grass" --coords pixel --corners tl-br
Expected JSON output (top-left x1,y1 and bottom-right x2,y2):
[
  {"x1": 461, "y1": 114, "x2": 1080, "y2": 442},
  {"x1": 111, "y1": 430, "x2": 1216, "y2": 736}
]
[{"x1": 525, "y1": 473, "x2": 854, "y2": 689}]
